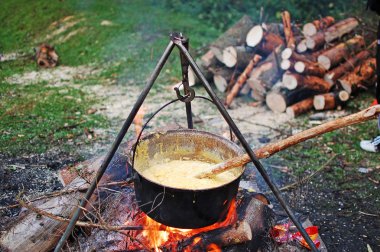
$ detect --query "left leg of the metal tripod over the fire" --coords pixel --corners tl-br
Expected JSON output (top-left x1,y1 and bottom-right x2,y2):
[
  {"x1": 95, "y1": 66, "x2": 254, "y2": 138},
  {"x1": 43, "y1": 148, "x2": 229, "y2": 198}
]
[{"x1": 54, "y1": 41, "x2": 174, "y2": 252}]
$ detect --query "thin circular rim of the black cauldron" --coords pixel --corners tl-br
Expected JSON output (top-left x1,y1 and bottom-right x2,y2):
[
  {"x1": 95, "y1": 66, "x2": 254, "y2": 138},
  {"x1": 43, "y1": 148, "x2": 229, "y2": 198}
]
[{"x1": 131, "y1": 129, "x2": 246, "y2": 192}]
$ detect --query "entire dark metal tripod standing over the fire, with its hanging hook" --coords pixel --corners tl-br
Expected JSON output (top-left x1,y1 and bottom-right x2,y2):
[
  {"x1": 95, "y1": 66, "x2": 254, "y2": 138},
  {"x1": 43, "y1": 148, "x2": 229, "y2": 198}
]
[{"x1": 54, "y1": 33, "x2": 318, "y2": 252}]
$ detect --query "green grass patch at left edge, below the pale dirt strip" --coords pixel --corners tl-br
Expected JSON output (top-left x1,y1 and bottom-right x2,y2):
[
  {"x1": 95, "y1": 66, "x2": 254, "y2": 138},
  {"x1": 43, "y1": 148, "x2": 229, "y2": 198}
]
[{"x1": 0, "y1": 84, "x2": 107, "y2": 154}]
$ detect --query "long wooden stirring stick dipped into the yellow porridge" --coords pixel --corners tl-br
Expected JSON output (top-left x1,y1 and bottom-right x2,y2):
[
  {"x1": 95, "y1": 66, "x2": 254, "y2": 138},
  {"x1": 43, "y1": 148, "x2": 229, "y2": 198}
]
[{"x1": 195, "y1": 105, "x2": 380, "y2": 178}]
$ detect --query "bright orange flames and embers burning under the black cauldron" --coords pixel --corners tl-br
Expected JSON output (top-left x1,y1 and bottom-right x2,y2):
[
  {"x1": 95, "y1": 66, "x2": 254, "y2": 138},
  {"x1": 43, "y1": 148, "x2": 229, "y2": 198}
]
[{"x1": 126, "y1": 200, "x2": 237, "y2": 251}]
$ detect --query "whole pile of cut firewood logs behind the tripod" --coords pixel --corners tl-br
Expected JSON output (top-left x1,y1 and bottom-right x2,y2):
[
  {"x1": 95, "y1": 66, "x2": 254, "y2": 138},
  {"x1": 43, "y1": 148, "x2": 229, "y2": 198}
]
[{"x1": 194, "y1": 11, "x2": 376, "y2": 117}]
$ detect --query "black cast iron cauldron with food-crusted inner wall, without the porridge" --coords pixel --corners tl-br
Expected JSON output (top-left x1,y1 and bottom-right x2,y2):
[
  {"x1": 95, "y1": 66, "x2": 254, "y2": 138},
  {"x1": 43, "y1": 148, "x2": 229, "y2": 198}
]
[{"x1": 133, "y1": 130, "x2": 244, "y2": 228}]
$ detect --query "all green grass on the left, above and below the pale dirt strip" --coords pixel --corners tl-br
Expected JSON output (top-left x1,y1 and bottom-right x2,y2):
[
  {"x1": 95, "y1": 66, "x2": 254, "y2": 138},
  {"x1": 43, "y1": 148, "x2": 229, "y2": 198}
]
[{"x1": 0, "y1": 0, "x2": 218, "y2": 154}]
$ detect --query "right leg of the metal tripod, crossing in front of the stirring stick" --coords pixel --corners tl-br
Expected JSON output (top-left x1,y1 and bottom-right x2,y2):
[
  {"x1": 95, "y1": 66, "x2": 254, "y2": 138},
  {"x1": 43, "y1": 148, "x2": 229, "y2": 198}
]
[{"x1": 176, "y1": 43, "x2": 318, "y2": 251}]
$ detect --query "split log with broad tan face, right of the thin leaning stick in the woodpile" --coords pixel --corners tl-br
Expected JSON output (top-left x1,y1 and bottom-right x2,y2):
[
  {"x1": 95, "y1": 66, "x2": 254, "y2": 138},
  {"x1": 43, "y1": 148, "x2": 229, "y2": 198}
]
[{"x1": 247, "y1": 48, "x2": 281, "y2": 101}]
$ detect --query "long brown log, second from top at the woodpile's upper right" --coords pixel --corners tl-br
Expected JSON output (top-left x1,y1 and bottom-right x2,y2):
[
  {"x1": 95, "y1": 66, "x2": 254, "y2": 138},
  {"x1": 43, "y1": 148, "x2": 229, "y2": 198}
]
[{"x1": 306, "y1": 18, "x2": 359, "y2": 51}]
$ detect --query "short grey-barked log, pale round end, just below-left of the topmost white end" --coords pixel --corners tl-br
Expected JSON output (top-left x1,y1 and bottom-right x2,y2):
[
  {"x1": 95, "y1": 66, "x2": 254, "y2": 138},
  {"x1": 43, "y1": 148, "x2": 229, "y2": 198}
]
[{"x1": 223, "y1": 46, "x2": 254, "y2": 68}]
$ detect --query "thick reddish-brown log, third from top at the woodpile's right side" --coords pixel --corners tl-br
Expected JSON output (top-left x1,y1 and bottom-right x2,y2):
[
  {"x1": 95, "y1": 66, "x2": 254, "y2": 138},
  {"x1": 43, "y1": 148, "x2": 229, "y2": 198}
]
[{"x1": 318, "y1": 36, "x2": 365, "y2": 70}]
